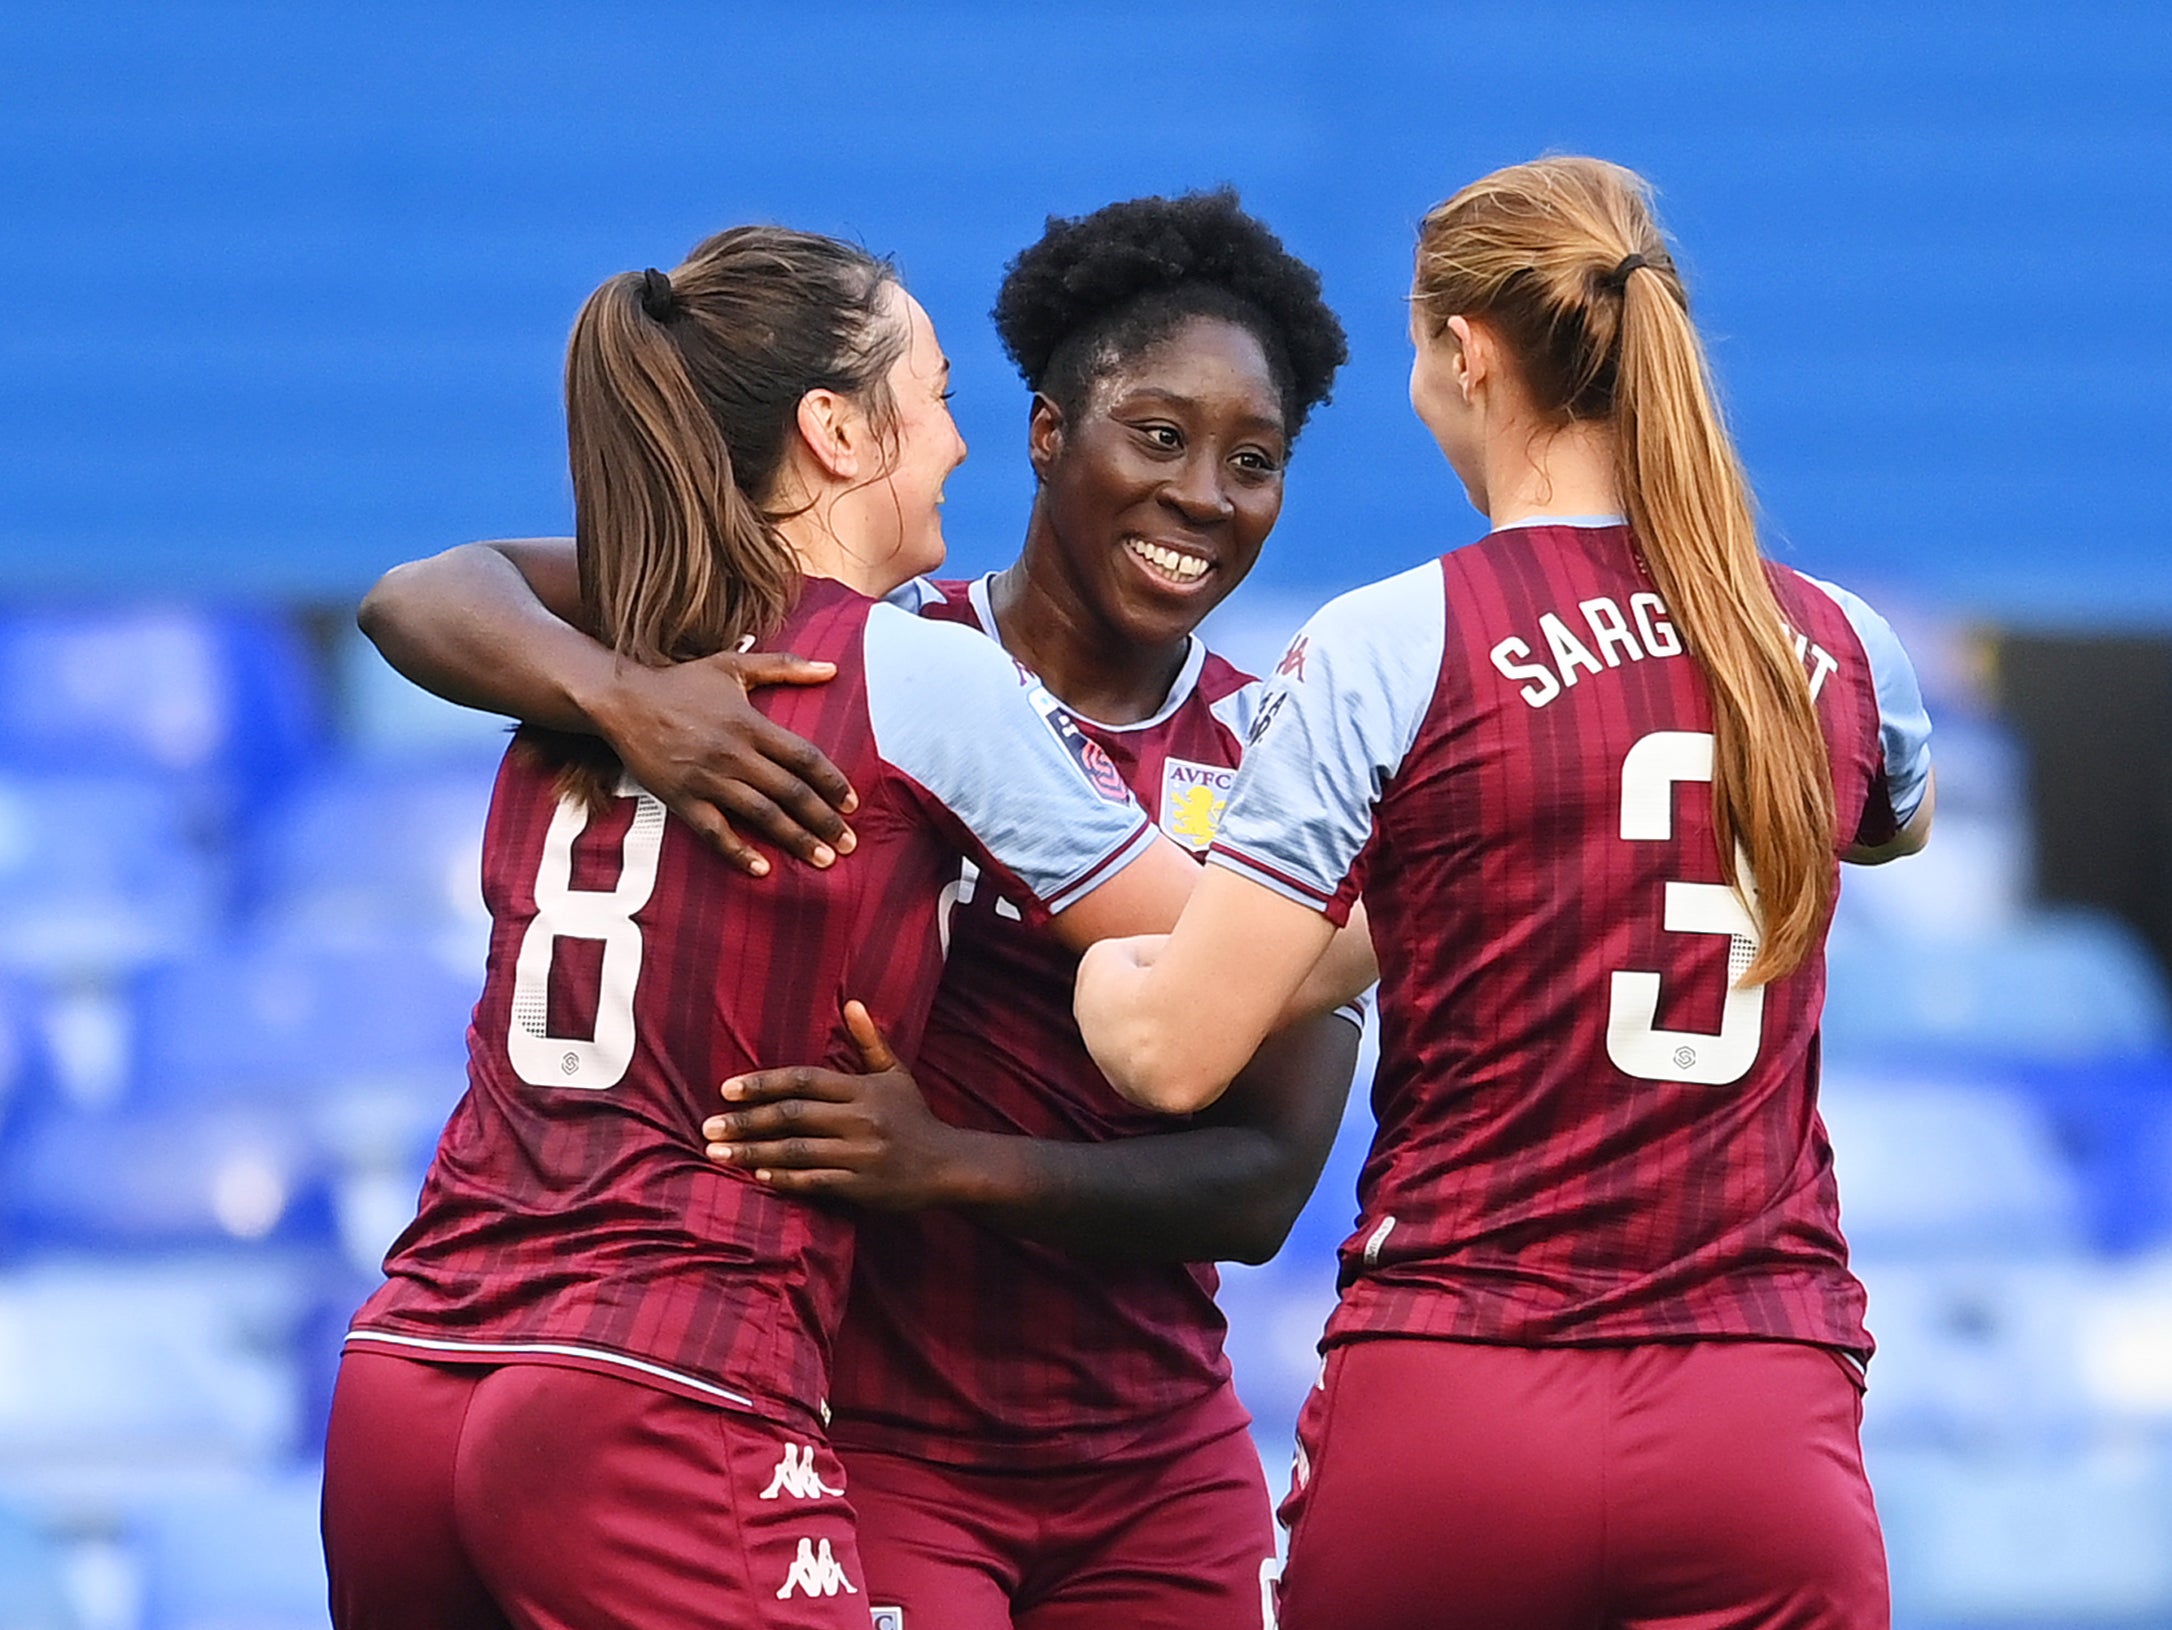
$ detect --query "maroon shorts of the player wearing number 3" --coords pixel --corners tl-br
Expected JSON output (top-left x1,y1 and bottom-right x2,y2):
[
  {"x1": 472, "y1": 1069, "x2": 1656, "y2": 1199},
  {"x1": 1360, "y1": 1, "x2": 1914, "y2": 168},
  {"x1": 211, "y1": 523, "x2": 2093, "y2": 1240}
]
[{"x1": 1281, "y1": 1339, "x2": 1887, "y2": 1630}]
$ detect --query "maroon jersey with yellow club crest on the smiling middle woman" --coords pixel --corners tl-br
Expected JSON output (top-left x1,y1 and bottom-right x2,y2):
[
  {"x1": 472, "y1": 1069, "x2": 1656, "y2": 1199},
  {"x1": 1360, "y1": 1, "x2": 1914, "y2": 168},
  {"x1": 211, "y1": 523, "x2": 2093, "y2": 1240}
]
[{"x1": 832, "y1": 578, "x2": 1258, "y2": 1467}]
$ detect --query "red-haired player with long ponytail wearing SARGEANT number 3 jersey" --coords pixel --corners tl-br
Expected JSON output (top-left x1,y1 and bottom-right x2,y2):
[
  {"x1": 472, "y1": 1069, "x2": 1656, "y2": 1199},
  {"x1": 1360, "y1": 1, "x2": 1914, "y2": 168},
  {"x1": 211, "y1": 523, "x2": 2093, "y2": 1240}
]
[{"x1": 1077, "y1": 159, "x2": 1931, "y2": 1630}]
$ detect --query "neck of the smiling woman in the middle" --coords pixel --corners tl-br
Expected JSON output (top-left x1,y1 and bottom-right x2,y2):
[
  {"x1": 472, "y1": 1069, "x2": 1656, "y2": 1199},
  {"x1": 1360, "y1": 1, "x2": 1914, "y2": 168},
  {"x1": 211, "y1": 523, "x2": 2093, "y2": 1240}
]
[{"x1": 988, "y1": 550, "x2": 1190, "y2": 724}]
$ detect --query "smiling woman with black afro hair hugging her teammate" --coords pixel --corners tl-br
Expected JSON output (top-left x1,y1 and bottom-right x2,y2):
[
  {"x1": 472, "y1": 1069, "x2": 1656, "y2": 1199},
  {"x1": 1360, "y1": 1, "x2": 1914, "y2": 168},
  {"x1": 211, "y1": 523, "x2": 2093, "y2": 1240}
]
[{"x1": 363, "y1": 189, "x2": 1358, "y2": 1630}]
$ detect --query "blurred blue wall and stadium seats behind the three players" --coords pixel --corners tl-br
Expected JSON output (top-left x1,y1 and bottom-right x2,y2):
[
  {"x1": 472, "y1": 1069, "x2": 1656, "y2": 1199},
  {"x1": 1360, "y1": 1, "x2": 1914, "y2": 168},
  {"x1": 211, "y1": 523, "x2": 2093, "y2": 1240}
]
[{"x1": 0, "y1": 0, "x2": 2172, "y2": 1630}]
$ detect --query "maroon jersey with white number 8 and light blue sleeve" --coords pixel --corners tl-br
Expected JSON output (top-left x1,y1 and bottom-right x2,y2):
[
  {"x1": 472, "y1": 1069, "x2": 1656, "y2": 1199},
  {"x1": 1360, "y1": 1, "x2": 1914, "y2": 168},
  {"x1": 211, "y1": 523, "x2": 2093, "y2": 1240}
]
[{"x1": 348, "y1": 578, "x2": 1153, "y2": 1424}]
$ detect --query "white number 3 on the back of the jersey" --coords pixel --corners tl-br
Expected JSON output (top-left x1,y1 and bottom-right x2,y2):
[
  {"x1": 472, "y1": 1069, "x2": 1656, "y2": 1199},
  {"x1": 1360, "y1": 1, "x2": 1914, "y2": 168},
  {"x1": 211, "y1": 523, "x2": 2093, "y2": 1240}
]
[{"x1": 1607, "y1": 730, "x2": 1764, "y2": 1087}]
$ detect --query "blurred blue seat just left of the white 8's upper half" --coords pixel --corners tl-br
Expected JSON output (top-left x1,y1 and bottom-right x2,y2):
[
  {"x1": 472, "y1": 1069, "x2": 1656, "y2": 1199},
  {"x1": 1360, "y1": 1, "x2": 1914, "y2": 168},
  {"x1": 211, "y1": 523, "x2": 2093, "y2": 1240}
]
[{"x1": 261, "y1": 754, "x2": 497, "y2": 969}]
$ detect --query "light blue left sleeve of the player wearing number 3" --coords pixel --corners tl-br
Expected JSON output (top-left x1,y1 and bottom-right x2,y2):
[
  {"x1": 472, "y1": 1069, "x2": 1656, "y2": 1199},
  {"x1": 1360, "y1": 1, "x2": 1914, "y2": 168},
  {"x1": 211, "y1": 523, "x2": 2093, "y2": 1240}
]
[{"x1": 1208, "y1": 561, "x2": 1447, "y2": 908}]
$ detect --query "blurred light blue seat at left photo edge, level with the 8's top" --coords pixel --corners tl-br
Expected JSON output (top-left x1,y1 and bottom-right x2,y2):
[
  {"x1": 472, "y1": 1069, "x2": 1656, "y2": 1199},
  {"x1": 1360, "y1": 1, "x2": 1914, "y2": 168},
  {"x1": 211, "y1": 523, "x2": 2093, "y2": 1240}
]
[{"x1": 0, "y1": 769, "x2": 224, "y2": 980}]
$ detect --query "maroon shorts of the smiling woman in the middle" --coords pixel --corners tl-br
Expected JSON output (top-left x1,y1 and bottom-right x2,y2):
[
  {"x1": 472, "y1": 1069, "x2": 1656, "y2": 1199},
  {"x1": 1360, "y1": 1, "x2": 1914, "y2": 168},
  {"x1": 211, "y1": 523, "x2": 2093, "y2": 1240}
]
[{"x1": 838, "y1": 1390, "x2": 1275, "y2": 1630}]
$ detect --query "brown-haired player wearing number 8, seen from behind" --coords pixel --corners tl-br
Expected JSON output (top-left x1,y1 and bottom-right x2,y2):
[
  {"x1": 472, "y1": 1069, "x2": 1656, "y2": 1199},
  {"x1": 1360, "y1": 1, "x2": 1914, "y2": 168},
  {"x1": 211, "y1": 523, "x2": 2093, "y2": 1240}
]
[{"x1": 324, "y1": 228, "x2": 1197, "y2": 1630}]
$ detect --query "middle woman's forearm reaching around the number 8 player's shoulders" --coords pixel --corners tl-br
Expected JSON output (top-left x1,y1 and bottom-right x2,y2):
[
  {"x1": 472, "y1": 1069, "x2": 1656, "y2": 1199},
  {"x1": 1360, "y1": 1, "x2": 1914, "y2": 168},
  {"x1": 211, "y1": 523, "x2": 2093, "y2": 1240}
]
[{"x1": 356, "y1": 543, "x2": 617, "y2": 735}]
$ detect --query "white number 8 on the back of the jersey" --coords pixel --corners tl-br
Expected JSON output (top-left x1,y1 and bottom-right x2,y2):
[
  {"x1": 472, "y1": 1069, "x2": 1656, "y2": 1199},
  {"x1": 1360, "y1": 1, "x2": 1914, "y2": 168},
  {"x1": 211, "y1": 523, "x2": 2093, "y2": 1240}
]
[{"x1": 506, "y1": 780, "x2": 665, "y2": 1091}]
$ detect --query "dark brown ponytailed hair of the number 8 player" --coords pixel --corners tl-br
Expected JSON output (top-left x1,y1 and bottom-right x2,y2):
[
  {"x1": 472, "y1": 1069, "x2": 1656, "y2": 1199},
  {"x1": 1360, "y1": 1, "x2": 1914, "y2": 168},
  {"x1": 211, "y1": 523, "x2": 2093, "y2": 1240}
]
[{"x1": 551, "y1": 226, "x2": 906, "y2": 806}]
